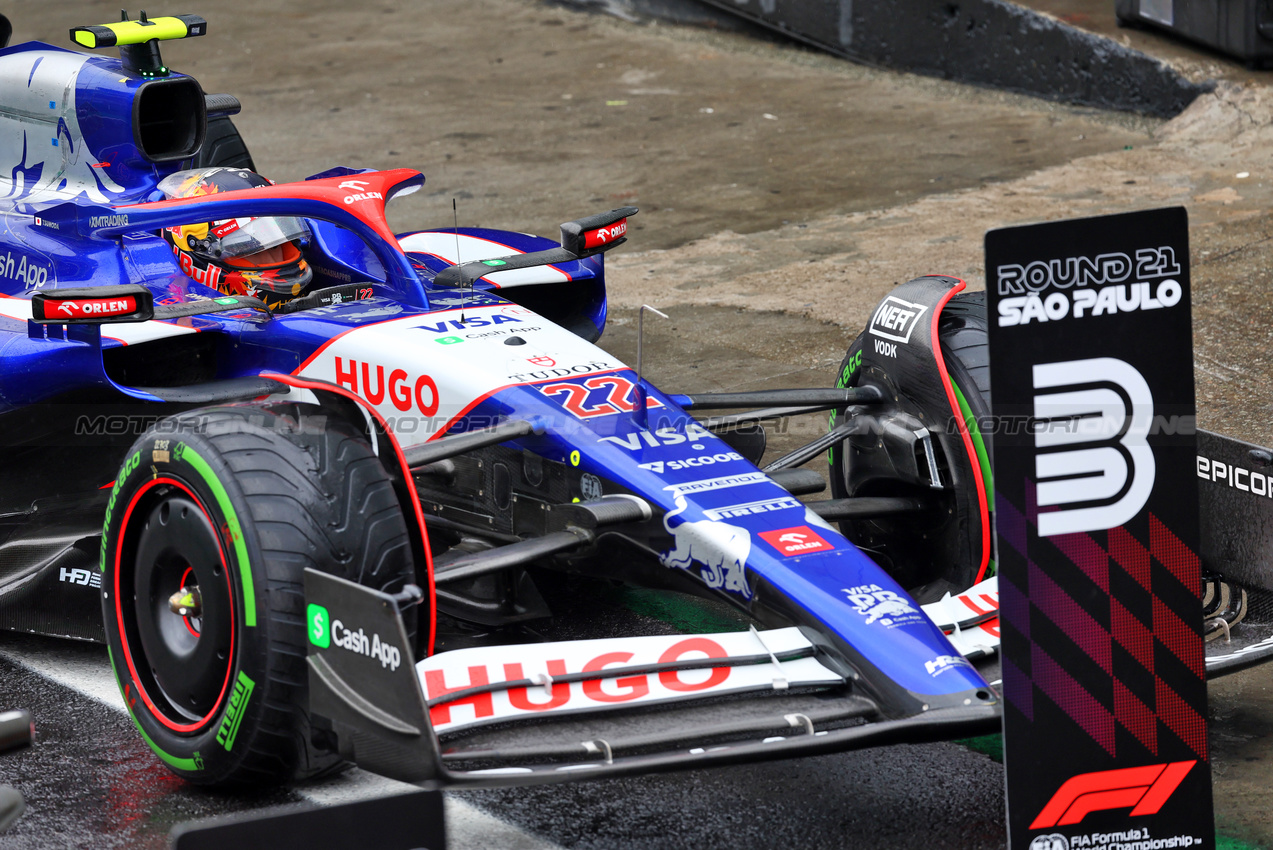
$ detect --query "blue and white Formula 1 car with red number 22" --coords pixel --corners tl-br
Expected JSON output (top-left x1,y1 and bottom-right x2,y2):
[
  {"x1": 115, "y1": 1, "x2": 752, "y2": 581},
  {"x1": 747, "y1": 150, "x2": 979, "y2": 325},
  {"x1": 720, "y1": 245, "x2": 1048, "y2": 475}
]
[{"x1": 0, "y1": 15, "x2": 1257, "y2": 799}]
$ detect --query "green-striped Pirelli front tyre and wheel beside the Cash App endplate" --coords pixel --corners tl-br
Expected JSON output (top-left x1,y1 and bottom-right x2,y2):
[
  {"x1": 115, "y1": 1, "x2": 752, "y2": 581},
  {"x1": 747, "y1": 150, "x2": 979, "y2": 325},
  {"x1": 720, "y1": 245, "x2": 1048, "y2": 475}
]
[{"x1": 102, "y1": 405, "x2": 414, "y2": 786}]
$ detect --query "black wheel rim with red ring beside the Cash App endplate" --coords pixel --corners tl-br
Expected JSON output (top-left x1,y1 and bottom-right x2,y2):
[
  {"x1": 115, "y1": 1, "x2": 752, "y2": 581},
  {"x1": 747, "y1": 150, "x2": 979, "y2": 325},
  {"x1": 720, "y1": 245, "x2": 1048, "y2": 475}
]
[{"x1": 115, "y1": 477, "x2": 236, "y2": 734}]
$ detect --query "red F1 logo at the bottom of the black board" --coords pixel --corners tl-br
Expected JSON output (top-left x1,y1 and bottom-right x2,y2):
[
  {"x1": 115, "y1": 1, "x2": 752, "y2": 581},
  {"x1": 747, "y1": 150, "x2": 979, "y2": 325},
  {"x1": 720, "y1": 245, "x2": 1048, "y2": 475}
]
[{"x1": 1030, "y1": 758, "x2": 1198, "y2": 830}]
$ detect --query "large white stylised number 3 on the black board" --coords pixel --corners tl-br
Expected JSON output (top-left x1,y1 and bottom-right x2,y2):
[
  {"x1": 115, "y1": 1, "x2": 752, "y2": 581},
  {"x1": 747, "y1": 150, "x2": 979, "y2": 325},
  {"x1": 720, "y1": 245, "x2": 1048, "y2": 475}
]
[{"x1": 1034, "y1": 358, "x2": 1156, "y2": 537}]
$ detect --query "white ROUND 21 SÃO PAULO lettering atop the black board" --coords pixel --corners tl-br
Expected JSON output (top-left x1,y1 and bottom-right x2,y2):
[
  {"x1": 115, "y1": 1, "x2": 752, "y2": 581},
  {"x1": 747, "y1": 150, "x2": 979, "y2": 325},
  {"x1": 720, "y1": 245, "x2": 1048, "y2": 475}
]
[{"x1": 995, "y1": 246, "x2": 1184, "y2": 327}]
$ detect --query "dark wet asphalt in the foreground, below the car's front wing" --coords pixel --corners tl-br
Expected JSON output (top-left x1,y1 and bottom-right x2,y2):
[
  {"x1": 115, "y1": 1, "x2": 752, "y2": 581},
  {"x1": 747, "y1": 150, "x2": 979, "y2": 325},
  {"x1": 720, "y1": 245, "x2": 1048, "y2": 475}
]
[{"x1": 0, "y1": 615, "x2": 1004, "y2": 850}]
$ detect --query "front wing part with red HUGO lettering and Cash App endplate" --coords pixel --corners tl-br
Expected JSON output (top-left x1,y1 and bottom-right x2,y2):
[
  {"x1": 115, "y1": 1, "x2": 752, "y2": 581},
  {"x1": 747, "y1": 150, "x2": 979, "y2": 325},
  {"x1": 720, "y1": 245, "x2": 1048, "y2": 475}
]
[{"x1": 306, "y1": 570, "x2": 1001, "y2": 788}]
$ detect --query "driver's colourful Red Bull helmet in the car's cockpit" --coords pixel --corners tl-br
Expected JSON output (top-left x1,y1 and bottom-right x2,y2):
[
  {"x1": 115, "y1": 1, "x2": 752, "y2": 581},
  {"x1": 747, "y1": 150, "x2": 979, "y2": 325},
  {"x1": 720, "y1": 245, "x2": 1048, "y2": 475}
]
[{"x1": 159, "y1": 168, "x2": 314, "y2": 308}]
